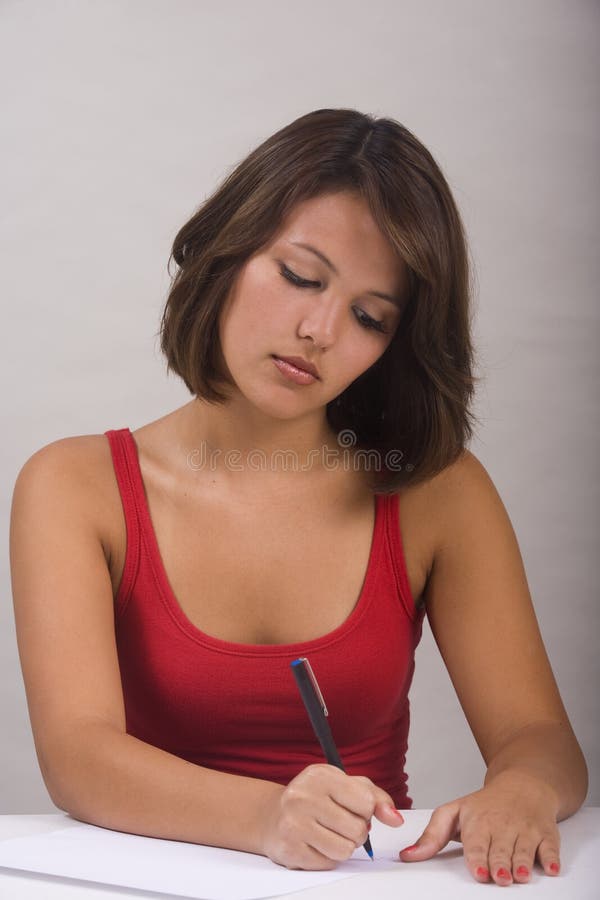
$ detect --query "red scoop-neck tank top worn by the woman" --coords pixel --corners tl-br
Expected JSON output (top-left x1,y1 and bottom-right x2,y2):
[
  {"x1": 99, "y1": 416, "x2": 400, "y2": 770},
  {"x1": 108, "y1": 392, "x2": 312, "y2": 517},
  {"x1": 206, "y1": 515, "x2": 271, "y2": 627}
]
[{"x1": 105, "y1": 428, "x2": 424, "y2": 809}]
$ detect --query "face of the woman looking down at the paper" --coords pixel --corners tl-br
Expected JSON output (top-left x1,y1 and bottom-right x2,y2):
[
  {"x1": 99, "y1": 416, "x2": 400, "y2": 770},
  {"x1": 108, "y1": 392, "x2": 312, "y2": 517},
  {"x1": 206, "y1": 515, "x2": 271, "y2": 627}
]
[{"x1": 219, "y1": 192, "x2": 406, "y2": 419}]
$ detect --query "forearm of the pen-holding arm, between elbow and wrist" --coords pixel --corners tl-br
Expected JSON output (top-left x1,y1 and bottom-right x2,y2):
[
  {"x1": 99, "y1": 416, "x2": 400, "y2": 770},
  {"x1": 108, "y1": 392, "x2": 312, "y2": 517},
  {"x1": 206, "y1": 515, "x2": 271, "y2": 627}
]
[{"x1": 46, "y1": 721, "x2": 284, "y2": 853}]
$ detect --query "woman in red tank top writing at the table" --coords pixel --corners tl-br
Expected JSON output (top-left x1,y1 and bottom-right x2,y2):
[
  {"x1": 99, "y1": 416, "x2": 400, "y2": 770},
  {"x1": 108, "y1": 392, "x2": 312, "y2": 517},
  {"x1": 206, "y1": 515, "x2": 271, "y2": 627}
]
[{"x1": 11, "y1": 109, "x2": 587, "y2": 885}]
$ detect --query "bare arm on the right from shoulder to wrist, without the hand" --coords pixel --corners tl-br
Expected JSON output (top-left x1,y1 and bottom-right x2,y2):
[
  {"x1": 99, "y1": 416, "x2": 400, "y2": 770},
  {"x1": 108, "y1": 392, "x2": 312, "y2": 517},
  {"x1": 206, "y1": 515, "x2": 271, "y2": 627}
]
[{"x1": 427, "y1": 454, "x2": 587, "y2": 818}]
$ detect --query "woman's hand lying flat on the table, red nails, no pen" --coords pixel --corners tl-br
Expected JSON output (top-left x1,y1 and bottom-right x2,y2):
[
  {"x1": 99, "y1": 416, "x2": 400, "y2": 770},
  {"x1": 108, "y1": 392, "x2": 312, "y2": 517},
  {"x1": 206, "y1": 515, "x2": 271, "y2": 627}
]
[{"x1": 400, "y1": 772, "x2": 560, "y2": 886}]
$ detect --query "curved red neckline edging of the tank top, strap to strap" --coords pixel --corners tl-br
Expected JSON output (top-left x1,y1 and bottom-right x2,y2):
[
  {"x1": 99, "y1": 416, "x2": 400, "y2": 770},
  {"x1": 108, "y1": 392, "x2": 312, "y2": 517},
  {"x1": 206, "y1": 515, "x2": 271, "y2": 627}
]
[{"x1": 112, "y1": 427, "x2": 397, "y2": 656}]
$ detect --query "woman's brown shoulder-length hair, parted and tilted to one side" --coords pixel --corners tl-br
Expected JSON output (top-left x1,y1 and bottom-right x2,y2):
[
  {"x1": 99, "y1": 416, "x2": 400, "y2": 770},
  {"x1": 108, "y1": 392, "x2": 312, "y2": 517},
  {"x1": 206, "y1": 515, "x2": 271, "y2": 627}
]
[{"x1": 159, "y1": 109, "x2": 478, "y2": 493}]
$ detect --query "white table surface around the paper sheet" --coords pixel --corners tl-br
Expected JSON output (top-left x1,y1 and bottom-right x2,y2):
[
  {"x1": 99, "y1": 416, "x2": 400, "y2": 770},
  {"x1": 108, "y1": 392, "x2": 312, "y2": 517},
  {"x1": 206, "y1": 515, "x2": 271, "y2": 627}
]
[{"x1": 0, "y1": 807, "x2": 600, "y2": 900}]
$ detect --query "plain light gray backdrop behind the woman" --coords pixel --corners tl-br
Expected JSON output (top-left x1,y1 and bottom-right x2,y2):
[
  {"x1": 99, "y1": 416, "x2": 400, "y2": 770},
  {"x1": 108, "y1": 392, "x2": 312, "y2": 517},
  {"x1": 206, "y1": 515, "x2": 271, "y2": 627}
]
[{"x1": 0, "y1": 0, "x2": 600, "y2": 813}]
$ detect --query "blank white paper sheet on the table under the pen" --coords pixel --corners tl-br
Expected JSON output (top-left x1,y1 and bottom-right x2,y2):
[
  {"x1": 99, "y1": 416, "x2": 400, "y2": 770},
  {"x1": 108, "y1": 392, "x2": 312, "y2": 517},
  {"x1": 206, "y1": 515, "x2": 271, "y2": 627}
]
[{"x1": 0, "y1": 817, "x2": 406, "y2": 900}]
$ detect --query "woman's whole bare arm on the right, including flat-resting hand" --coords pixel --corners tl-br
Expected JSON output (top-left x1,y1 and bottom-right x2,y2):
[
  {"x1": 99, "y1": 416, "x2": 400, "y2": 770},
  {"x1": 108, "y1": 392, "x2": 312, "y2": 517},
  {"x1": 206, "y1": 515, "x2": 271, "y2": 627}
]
[{"x1": 400, "y1": 452, "x2": 587, "y2": 883}]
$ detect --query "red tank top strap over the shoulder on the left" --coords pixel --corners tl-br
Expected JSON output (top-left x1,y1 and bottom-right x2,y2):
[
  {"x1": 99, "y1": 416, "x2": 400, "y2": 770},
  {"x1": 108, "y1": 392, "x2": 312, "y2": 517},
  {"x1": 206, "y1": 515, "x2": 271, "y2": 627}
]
[{"x1": 104, "y1": 428, "x2": 146, "y2": 612}]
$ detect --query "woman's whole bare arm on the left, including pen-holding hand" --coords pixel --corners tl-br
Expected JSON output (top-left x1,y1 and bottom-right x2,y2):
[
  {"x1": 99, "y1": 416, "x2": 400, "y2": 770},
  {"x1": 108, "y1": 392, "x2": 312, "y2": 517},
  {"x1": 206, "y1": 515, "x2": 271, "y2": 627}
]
[{"x1": 10, "y1": 437, "x2": 402, "y2": 868}]
